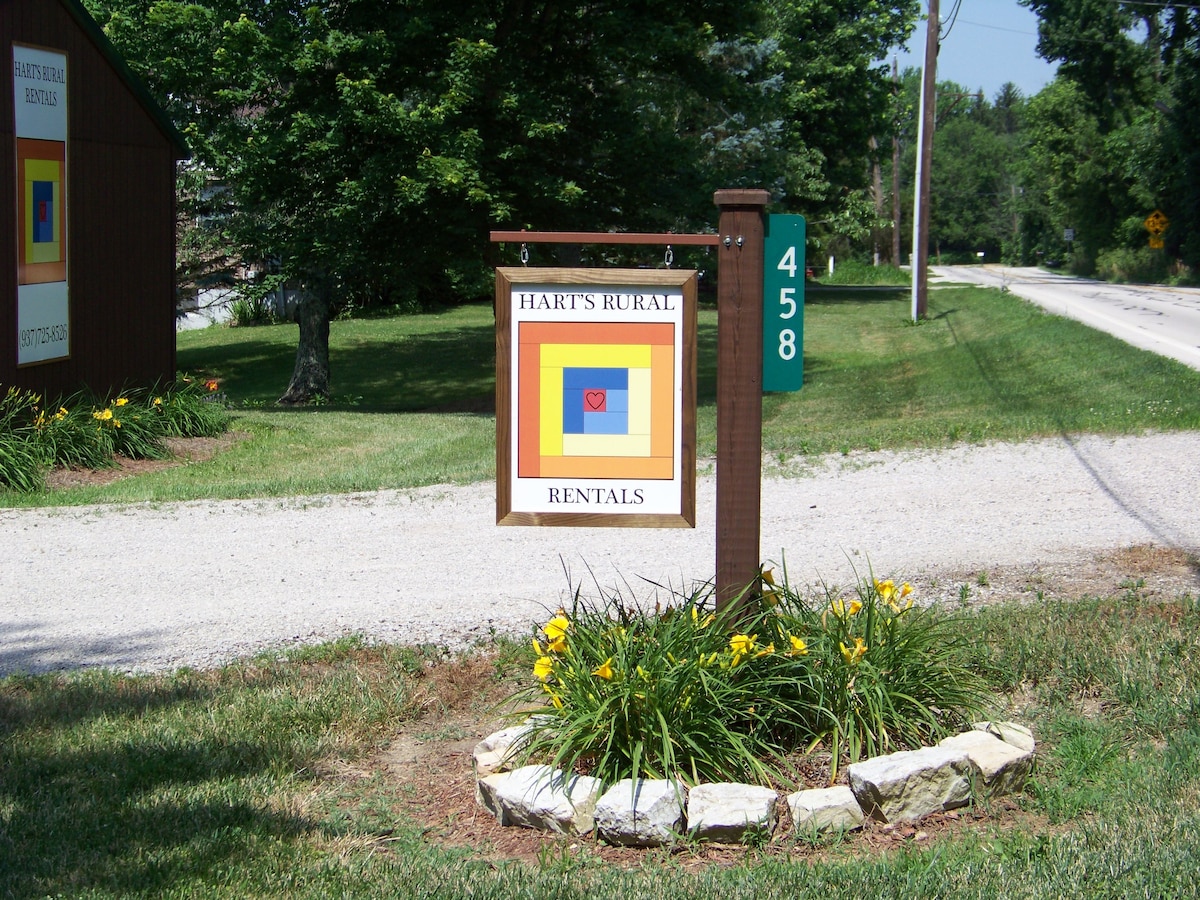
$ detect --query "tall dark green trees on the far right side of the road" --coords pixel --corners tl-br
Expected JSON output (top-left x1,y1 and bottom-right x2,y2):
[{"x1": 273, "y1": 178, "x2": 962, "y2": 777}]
[{"x1": 1022, "y1": 0, "x2": 1200, "y2": 272}]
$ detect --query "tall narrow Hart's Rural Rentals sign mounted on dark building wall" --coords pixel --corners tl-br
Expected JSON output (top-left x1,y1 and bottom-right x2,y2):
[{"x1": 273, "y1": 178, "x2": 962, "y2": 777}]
[{"x1": 12, "y1": 44, "x2": 71, "y2": 365}]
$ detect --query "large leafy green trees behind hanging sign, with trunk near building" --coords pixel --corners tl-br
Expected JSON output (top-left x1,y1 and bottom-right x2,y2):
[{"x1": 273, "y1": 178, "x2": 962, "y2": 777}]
[{"x1": 86, "y1": 0, "x2": 914, "y2": 402}]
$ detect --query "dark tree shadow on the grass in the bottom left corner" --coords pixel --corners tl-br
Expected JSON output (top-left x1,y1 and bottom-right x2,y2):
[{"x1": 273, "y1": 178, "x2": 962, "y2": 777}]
[{"x1": 0, "y1": 673, "x2": 314, "y2": 898}]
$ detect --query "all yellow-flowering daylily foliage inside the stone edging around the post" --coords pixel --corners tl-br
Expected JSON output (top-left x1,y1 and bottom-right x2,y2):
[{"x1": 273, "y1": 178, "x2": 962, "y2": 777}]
[{"x1": 516, "y1": 571, "x2": 986, "y2": 784}]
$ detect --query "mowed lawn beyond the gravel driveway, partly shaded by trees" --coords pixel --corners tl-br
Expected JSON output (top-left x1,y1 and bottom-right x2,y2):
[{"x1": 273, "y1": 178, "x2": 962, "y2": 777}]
[{"x1": 0, "y1": 287, "x2": 1200, "y2": 505}]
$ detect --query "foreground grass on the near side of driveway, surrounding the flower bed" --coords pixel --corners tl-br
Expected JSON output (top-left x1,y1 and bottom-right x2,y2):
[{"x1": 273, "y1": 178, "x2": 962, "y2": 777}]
[{"x1": 0, "y1": 586, "x2": 1200, "y2": 900}]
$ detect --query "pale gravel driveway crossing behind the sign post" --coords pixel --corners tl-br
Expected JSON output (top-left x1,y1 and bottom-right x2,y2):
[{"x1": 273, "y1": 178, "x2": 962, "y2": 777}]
[{"x1": 0, "y1": 432, "x2": 1200, "y2": 673}]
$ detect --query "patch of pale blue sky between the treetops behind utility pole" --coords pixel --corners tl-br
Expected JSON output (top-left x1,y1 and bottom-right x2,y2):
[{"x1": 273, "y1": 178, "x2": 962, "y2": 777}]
[{"x1": 887, "y1": 0, "x2": 1055, "y2": 101}]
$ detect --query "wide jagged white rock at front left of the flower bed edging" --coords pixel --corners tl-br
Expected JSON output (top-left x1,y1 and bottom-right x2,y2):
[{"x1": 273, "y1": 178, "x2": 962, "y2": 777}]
[{"x1": 475, "y1": 766, "x2": 601, "y2": 834}]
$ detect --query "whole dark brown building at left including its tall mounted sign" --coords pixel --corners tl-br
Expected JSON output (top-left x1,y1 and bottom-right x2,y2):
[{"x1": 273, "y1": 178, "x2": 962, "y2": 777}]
[{"x1": 0, "y1": 0, "x2": 186, "y2": 398}]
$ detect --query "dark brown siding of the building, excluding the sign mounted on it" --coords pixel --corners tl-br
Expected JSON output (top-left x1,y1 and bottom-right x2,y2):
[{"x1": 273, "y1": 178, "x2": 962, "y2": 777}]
[{"x1": 0, "y1": 0, "x2": 179, "y2": 398}]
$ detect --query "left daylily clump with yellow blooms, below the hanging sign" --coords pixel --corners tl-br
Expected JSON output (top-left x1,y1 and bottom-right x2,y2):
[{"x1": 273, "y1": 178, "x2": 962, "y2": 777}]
[{"x1": 517, "y1": 593, "x2": 817, "y2": 784}]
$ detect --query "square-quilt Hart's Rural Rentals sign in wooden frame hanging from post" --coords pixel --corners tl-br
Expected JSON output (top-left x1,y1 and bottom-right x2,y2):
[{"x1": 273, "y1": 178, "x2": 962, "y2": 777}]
[{"x1": 496, "y1": 268, "x2": 696, "y2": 528}]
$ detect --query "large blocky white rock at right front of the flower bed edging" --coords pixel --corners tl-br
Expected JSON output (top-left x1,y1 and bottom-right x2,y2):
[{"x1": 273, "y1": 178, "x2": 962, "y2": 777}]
[{"x1": 847, "y1": 746, "x2": 972, "y2": 822}]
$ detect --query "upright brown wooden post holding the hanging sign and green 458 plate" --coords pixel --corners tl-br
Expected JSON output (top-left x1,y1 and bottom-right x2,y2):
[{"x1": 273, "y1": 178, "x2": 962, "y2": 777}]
[{"x1": 713, "y1": 190, "x2": 770, "y2": 608}]
